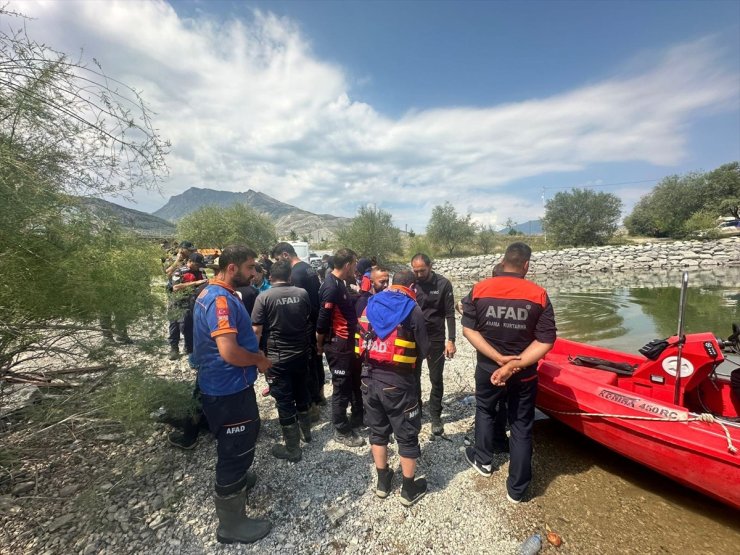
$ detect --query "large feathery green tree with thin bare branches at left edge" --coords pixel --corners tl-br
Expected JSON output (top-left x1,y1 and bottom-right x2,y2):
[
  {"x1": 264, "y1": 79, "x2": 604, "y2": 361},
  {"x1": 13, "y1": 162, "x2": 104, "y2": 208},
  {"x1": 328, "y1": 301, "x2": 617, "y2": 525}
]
[{"x1": 0, "y1": 8, "x2": 168, "y2": 374}]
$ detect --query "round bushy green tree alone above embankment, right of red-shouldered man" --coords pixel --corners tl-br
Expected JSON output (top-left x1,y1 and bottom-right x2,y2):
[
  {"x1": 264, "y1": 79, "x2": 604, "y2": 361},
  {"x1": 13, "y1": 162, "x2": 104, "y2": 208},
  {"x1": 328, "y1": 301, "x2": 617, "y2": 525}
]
[{"x1": 545, "y1": 189, "x2": 622, "y2": 246}]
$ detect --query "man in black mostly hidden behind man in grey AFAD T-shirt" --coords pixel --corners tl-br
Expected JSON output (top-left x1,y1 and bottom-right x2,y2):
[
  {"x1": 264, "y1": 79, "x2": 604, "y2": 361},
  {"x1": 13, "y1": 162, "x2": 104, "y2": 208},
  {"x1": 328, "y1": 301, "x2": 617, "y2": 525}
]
[{"x1": 272, "y1": 243, "x2": 326, "y2": 416}]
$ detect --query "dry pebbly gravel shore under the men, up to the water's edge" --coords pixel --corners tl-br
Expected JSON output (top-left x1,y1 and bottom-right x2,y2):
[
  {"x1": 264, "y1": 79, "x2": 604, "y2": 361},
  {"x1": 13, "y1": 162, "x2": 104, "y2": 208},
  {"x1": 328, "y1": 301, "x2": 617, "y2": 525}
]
[{"x1": 0, "y1": 312, "x2": 556, "y2": 554}]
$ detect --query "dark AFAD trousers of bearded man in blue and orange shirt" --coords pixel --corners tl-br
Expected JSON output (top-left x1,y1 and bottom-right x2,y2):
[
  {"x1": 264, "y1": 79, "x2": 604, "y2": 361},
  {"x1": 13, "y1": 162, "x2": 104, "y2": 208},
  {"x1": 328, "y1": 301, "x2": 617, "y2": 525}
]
[{"x1": 201, "y1": 387, "x2": 260, "y2": 496}]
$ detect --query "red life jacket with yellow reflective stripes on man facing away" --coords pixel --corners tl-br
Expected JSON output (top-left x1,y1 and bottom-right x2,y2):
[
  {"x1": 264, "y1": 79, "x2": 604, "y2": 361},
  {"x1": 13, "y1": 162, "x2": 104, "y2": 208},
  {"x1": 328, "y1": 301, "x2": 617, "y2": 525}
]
[{"x1": 355, "y1": 308, "x2": 417, "y2": 370}]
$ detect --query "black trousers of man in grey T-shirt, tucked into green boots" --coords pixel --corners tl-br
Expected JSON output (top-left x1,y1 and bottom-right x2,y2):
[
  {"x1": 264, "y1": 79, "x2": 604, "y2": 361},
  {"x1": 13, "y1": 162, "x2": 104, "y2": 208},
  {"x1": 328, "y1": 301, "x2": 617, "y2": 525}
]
[{"x1": 267, "y1": 353, "x2": 309, "y2": 426}]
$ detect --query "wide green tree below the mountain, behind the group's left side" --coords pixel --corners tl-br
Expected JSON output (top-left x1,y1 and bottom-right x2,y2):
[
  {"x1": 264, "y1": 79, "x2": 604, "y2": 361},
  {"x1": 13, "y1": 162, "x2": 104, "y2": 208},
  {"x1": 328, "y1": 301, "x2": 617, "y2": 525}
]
[{"x1": 177, "y1": 204, "x2": 277, "y2": 252}]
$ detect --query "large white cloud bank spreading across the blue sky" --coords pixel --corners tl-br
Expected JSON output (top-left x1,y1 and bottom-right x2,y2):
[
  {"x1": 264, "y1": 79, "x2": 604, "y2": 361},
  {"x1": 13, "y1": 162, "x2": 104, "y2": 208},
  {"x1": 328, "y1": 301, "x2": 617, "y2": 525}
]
[{"x1": 12, "y1": 1, "x2": 739, "y2": 231}]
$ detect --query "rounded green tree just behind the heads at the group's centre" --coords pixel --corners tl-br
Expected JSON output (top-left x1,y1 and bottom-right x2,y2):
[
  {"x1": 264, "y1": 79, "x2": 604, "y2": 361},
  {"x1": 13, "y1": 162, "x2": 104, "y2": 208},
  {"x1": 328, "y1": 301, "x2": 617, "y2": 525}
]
[{"x1": 336, "y1": 206, "x2": 403, "y2": 261}]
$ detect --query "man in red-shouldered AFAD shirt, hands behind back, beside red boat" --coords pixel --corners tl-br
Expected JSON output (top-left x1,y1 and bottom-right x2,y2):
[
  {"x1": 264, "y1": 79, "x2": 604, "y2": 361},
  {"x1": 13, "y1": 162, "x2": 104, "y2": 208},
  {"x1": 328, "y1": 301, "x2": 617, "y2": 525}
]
[{"x1": 462, "y1": 243, "x2": 556, "y2": 503}]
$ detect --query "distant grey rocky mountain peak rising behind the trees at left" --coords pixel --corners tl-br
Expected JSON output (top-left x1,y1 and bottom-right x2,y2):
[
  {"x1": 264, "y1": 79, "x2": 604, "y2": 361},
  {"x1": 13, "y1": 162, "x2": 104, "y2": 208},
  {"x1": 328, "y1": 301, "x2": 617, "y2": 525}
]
[{"x1": 154, "y1": 187, "x2": 349, "y2": 241}]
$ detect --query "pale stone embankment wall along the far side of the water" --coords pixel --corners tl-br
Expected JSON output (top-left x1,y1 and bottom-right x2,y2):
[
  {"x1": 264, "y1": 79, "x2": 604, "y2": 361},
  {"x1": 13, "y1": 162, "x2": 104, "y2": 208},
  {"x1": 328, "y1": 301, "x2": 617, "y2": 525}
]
[{"x1": 434, "y1": 237, "x2": 740, "y2": 280}]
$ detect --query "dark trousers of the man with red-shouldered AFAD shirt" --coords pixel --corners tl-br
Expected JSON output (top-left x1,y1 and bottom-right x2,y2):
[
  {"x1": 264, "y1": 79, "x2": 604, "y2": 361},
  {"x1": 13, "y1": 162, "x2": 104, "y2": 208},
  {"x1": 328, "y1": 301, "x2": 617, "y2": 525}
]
[{"x1": 475, "y1": 366, "x2": 537, "y2": 499}]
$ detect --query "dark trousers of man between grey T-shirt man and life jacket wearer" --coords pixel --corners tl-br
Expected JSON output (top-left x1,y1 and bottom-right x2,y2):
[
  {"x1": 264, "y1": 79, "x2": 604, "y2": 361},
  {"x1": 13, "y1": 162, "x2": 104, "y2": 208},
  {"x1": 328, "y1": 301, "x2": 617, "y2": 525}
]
[{"x1": 324, "y1": 337, "x2": 362, "y2": 434}]
